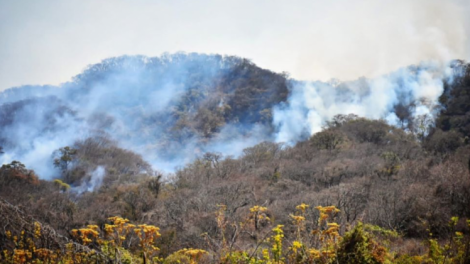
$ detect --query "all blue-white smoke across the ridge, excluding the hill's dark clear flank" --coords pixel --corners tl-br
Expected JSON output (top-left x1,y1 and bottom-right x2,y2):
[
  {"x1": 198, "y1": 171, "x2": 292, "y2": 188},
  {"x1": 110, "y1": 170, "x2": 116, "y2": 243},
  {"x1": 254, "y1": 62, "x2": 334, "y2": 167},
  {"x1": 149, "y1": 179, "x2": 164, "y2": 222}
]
[{"x1": 0, "y1": 54, "x2": 464, "y2": 177}]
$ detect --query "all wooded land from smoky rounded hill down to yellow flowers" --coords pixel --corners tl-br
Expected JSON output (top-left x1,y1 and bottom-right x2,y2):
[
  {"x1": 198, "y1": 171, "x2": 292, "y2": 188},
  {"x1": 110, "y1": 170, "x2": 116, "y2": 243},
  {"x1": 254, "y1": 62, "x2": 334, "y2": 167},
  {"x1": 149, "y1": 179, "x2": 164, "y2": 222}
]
[{"x1": 0, "y1": 54, "x2": 470, "y2": 263}]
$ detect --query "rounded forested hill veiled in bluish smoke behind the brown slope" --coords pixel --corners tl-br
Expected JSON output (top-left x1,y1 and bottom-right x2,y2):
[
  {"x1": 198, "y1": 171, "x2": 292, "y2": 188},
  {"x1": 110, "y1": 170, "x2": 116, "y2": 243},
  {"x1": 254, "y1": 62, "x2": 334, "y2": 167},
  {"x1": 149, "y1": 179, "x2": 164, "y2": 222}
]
[{"x1": 0, "y1": 54, "x2": 288, "y2": 174}]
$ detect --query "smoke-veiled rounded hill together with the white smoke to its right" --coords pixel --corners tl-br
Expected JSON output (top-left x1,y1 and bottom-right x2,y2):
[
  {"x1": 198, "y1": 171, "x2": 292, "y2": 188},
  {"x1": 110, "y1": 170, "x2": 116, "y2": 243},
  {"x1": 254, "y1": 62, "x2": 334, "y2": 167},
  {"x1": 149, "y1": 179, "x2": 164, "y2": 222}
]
[{"x1": 0, "y1": 53, "x2": 465, "y2": 178}]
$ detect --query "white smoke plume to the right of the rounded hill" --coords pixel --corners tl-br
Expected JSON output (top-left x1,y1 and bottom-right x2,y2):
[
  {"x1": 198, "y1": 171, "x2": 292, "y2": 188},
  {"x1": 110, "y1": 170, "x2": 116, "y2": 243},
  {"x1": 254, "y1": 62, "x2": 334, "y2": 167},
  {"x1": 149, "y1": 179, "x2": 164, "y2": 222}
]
[{"x1": 273, "y1": 63, "x2": 454, "y2": 143}]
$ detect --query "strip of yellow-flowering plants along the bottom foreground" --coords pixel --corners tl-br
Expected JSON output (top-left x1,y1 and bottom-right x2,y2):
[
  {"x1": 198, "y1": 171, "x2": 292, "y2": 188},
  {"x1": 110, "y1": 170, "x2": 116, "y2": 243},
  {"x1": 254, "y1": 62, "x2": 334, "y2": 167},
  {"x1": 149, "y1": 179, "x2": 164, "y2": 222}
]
[{"x1": 4, "y1": 203, "x2": 470, "y2": 264}]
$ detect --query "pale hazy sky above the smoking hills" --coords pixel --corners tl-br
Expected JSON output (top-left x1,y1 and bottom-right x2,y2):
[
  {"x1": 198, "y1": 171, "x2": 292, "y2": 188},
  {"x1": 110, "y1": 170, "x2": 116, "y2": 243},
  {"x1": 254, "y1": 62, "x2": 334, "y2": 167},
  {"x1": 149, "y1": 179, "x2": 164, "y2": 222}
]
[{"x1": 0, "y1": 0, "x2": 470, "y2": 91}]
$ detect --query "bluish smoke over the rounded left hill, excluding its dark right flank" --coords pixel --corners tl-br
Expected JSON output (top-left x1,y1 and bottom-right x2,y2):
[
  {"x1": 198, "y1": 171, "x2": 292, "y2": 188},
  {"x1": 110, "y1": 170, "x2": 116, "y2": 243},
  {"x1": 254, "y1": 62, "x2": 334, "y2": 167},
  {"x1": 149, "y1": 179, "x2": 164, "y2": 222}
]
[{"x1": 0, "y1": 53, "x2": 269, "y2": 179}]
